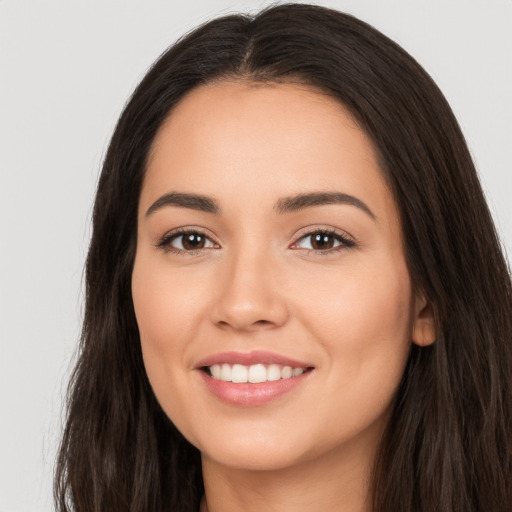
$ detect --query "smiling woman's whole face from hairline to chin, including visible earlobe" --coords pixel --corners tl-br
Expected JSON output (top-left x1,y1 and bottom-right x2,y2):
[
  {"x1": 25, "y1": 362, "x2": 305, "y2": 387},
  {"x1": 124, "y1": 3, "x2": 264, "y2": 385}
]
[{"x1": 132, "y1": 82, "x2": 428, "y2": 469}]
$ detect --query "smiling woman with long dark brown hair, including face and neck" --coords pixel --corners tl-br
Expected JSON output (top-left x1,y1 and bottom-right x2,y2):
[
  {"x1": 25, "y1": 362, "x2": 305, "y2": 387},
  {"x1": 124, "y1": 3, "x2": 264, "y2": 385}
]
[{"x1": 56, "y1": 4, "x2": 512, "y2": 512}]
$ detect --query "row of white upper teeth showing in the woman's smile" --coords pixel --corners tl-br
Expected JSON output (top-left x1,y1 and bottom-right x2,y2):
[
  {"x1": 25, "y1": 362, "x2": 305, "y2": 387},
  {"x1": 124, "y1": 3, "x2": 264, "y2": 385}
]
[{"x1": 205, "y1": 363, "x2": 305, "y2": 384}]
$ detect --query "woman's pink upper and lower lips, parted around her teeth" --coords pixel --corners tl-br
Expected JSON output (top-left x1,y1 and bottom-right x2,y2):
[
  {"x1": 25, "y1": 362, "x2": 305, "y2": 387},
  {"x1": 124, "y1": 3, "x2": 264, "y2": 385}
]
[{"x1": 195, "y1": 350, "x2": 314, "y2": 407}]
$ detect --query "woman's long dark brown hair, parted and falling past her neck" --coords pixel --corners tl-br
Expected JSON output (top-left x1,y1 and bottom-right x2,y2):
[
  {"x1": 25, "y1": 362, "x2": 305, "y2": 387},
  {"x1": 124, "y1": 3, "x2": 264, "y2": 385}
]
[{"x1": 55, "y1": 4, "x2": 512, "y2": 512}]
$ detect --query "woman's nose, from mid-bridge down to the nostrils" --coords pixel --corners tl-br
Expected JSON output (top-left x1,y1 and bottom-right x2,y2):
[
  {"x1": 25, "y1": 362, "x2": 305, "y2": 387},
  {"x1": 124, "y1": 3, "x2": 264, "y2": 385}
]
[{"x1": 211, "y1": 251, "x2": 289, "y2": 331}]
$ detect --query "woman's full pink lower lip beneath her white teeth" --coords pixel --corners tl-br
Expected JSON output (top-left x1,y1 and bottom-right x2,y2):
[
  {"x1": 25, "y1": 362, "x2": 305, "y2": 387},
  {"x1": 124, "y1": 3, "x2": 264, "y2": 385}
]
[{"x1": 198, "y1": 370, "x2": 312, "y2": 407}]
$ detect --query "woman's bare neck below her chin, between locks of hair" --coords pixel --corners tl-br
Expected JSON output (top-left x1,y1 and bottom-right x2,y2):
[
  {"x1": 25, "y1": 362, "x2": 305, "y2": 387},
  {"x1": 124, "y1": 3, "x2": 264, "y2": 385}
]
[{"x1": 201, "y1": 440, "x2": 373, "y2": 512}]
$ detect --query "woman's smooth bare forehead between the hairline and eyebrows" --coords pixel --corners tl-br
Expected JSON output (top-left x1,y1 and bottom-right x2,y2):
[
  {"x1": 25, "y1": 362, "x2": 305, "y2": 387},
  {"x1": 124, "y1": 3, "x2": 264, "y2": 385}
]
[{"x1": 141, "y1": 81, "x2": 394, "y2": 224}]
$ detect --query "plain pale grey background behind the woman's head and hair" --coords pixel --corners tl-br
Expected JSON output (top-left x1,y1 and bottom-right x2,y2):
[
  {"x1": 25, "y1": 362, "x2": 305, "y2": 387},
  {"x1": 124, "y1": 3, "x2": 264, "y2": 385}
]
[{"x1": 0, "y1": 0, "x2": 512, "y2": 512}]
